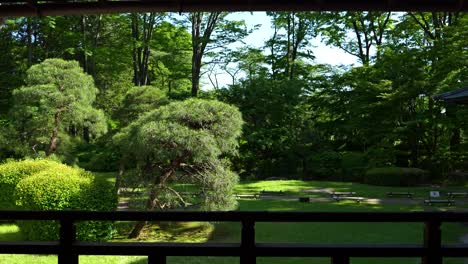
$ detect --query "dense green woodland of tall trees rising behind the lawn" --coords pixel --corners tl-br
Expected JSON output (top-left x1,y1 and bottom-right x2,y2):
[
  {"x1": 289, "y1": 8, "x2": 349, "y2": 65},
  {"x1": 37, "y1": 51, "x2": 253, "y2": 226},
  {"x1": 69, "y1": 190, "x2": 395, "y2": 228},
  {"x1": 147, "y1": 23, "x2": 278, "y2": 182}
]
[{"x1": 0, "y1": 12, "x2": 468, "y2": 186}]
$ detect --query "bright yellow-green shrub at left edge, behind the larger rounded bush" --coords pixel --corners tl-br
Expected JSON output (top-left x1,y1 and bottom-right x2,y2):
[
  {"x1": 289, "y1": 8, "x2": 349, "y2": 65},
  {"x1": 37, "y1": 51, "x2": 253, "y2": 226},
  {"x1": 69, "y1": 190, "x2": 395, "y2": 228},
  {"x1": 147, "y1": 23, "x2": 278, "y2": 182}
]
[{"x1": 0, "y1": 159, "x2": 67, "y2": 209}]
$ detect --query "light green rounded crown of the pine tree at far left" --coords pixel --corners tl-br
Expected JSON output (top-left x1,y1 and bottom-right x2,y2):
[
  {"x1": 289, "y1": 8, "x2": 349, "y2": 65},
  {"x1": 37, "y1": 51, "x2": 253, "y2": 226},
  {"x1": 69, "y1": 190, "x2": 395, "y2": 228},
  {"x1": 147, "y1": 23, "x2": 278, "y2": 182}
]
[{"x1": 11, "y1": 59, "x2": 107, "y2": 155}]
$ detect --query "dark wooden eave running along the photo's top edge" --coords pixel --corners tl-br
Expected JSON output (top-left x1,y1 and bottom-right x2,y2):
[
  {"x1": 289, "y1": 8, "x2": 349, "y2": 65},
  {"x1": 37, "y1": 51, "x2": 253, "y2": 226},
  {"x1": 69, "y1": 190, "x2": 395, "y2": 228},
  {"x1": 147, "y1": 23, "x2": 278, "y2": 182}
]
[{"x1": 0, "y1": 0, "x2": 468, "y2": 17}]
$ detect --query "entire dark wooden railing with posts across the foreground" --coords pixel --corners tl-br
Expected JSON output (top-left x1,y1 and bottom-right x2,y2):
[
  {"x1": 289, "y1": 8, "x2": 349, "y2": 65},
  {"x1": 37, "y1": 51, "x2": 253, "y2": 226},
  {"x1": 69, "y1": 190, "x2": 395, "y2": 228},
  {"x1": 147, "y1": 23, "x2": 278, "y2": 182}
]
[{"x1": 0, "y1": 211, "x2": 468, "y2": 264}]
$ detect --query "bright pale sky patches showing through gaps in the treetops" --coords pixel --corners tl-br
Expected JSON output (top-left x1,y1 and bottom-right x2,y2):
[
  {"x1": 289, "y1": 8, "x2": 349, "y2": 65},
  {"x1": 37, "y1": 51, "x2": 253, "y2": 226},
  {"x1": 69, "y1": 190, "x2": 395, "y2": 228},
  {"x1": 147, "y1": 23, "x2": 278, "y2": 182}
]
[{"x1": 203, "y1": 12, "x2": 357, "y2": 88}]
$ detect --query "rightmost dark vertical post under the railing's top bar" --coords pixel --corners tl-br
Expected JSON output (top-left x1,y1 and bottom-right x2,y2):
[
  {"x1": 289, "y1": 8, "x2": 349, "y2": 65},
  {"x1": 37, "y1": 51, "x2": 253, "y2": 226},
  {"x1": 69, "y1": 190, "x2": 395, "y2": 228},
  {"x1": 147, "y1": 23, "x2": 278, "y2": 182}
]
[{"x1": 421, "y1": 220, "x2": 442, "y2": 264}]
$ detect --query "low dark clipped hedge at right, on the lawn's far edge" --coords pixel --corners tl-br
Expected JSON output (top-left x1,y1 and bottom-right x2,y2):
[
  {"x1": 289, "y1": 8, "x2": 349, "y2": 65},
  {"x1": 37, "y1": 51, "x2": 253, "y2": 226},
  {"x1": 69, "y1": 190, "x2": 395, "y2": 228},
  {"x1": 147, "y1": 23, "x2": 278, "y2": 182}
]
[{"x1": 364, "y1": 167, "x2": 428, "y2": 186}]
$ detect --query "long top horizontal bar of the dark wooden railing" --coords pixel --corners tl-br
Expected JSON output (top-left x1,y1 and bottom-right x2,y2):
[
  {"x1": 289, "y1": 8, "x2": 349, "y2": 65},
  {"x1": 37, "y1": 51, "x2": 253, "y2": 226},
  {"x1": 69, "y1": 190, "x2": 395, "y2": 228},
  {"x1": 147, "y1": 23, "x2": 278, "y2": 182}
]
[{"x1": 0, "y1": 210, "x2": 468, "y2": 223}]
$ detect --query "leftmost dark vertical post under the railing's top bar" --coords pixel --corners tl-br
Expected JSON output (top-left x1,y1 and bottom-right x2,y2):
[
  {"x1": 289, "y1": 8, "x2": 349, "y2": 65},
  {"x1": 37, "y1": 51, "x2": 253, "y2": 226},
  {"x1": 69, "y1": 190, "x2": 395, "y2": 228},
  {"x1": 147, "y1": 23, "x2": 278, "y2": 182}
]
[{"x1": 58, "y1": 219, "x2": 78, "y2": 264}]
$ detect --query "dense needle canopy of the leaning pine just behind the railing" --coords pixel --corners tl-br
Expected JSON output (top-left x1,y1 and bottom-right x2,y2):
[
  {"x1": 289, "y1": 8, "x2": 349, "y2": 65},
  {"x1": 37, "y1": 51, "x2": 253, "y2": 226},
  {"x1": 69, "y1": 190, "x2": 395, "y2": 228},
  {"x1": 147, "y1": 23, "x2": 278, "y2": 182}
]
[{"x1": 115, "y1": 99, "x2": 242, "y2": 212}]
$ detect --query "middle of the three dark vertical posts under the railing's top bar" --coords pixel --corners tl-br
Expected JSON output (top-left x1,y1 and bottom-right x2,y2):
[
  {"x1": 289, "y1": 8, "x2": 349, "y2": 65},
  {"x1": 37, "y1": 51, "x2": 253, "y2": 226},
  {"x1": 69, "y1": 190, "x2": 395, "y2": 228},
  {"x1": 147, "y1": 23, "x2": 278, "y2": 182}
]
[{"x1": 240, "y1": 219, "x2": 257, "y2": 264}]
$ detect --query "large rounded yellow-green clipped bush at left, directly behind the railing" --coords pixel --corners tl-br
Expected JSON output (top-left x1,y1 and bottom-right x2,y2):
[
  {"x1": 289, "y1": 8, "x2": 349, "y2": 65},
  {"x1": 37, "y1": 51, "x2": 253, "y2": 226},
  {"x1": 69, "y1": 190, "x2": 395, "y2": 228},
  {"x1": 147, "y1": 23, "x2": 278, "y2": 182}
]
[{"x1": 15, "y1": 167, "x2": 117, "y2": 241}]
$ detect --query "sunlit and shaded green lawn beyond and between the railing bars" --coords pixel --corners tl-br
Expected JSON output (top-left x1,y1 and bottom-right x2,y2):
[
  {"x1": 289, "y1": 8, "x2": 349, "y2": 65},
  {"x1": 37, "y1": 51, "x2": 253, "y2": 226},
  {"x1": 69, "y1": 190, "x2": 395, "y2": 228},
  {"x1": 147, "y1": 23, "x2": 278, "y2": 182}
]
[{"x1": 0, "y1": 174, "x2": 468, "y2": 264}]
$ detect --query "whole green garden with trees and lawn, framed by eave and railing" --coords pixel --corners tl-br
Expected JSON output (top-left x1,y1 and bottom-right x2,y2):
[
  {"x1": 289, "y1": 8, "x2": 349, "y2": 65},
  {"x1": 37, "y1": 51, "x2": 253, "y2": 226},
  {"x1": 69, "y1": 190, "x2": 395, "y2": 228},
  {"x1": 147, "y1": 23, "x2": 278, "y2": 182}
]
[{"x1": 0, "y1": 9, "x2": 468, "y2": 264}]
